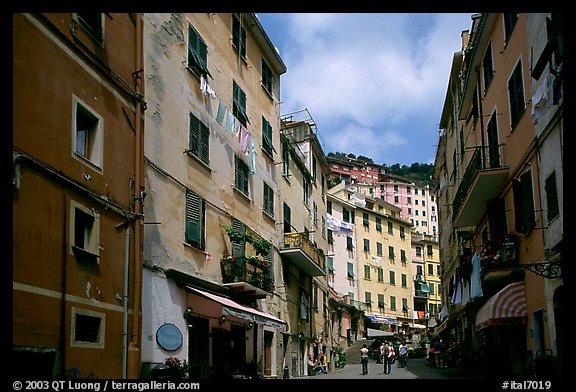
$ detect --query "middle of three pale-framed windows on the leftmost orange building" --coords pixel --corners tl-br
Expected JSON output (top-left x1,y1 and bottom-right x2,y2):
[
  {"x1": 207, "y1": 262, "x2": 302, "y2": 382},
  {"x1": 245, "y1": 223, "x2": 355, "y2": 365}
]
[{"x1": 70, "y1": 201, "x2": 100, "y2": 263}]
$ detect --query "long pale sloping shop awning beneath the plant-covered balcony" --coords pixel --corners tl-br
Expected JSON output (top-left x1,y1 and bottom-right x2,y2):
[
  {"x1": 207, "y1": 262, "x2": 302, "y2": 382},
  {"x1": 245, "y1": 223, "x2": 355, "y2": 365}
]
[{"x1": 186, "y1": 285, "x2": 286, "y2": 330}]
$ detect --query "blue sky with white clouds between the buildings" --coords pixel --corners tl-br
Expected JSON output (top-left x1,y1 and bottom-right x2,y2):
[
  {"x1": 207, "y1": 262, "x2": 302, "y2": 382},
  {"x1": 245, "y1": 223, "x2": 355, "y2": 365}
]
[{"x1": 257, "y1": 13, "x2": 472, "y2": 166}]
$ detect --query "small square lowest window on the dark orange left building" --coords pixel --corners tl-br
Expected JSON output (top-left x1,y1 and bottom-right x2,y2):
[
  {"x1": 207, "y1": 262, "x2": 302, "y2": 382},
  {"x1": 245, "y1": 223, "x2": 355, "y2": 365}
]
[{"x1": 70, "y1": 307, "x2": 106, "y2": 348}]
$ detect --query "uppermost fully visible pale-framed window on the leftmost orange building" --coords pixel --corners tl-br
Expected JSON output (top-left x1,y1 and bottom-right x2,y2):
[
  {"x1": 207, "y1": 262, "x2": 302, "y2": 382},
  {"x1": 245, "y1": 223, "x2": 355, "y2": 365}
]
[{"x1": 72, "y1": 97, "x2": 104, "y2": 169}]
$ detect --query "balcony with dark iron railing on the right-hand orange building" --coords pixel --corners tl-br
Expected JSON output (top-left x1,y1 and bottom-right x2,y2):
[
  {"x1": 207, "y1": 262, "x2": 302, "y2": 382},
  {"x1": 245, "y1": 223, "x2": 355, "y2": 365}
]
[{"x1": 452, "y1": 145, "x2": 509, "y2": 227}]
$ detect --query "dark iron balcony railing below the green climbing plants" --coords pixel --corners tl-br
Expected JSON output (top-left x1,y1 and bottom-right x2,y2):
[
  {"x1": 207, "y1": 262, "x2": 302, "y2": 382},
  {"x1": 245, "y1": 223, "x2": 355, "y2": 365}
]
[{"x1": 220, "y1": 256, "x2": 274, "y2": 292}]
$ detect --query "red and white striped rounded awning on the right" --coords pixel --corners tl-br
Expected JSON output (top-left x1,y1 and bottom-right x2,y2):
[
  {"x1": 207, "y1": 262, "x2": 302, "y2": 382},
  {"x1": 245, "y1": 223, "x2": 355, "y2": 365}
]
[{"x1": 476, "y1": 282, "x2": 528, "y2": 330}]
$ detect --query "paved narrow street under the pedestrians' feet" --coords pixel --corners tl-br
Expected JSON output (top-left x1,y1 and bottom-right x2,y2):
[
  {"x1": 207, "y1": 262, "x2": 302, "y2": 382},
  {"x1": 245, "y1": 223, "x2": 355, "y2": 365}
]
[{"x1": 306, "y1": 358, "x2": 482, "y2": 380}]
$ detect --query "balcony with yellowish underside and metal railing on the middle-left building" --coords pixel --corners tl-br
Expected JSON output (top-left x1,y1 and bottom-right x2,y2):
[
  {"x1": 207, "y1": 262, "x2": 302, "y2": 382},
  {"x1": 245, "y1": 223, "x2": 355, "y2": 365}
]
[{"x1": 279, "y1": 233, "x2": 326, "y2": 276}]
